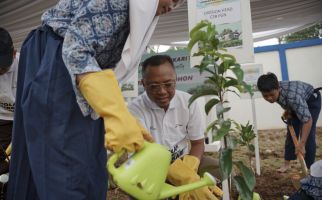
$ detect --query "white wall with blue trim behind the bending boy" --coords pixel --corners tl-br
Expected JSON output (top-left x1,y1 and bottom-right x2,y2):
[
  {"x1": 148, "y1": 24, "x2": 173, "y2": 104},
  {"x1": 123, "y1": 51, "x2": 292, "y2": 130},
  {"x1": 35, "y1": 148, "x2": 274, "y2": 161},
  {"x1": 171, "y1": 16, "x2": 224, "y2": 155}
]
[{"x1": 228, "y1": 45, "x2": 322, "y2": 130}]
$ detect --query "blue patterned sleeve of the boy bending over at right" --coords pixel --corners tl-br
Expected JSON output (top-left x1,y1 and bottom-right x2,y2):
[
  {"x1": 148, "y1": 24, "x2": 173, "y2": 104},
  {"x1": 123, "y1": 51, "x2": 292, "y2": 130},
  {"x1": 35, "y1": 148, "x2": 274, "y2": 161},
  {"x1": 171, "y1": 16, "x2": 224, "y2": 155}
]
[{"x1": 288, "y1": 96, "x2": 311, "y2": 123}]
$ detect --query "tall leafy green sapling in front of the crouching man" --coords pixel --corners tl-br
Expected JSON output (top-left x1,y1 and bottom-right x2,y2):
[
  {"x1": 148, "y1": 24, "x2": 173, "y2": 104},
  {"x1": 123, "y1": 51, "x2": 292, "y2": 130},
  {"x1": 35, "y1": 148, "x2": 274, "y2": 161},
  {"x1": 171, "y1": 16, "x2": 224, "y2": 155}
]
[{"x1": 188, "y1": 20, "x2": 258, "y2": 200}]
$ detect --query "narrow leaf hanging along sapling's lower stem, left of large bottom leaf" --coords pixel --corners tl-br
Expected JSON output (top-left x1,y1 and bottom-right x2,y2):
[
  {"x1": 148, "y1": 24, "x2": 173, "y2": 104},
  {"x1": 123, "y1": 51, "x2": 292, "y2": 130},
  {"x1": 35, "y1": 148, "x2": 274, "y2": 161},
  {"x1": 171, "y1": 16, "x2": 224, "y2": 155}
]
[{"x1": 219, "y1": 148, "x2": 233, "y2": 180}]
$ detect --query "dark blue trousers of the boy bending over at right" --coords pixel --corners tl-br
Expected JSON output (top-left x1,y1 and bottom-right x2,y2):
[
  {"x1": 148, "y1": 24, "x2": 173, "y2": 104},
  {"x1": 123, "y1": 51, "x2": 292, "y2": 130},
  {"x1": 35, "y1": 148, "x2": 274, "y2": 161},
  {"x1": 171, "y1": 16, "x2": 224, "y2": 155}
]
[{"x1": 284, "y1": 91, "x2": 321, "y2": 168}]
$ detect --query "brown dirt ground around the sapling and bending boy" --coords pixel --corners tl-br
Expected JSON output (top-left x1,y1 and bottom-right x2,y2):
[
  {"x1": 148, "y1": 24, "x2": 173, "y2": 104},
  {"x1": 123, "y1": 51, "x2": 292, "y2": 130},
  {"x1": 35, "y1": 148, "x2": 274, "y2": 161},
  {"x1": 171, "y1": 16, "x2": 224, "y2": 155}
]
[{"x1": 107, "y1": 127, "x2": 322, "y2": 200}]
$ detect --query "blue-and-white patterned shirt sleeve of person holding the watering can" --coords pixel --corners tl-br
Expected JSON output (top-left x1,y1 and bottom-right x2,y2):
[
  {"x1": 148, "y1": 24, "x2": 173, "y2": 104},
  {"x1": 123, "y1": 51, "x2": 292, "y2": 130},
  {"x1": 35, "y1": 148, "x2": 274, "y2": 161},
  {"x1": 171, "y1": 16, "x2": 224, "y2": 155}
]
[{"x1": 62, "y1": 1, "x2": 128, "y2": 116}]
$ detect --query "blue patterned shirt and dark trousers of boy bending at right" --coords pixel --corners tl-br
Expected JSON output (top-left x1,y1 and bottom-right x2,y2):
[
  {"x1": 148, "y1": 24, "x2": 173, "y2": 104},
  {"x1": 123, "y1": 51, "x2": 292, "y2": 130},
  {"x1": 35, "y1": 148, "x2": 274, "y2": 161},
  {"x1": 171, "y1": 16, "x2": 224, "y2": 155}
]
[{"x1": 277, "y1": 81, "x2": 321, "y2": 168}]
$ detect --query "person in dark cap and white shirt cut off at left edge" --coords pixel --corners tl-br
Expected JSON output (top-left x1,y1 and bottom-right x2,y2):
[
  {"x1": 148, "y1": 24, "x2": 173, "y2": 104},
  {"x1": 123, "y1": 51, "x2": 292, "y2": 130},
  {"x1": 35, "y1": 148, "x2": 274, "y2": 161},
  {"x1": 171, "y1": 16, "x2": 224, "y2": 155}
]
[{"x1": 0, "y1": 27, "x2": 19, "y2": 174}]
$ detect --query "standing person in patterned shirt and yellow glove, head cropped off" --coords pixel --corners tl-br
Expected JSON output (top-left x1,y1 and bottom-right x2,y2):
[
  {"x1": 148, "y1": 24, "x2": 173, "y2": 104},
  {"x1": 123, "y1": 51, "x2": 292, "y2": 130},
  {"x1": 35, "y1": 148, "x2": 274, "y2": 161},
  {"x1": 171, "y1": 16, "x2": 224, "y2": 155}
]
[{"x1": 7, "y1": 0, "x2": 182, "y2": 200}]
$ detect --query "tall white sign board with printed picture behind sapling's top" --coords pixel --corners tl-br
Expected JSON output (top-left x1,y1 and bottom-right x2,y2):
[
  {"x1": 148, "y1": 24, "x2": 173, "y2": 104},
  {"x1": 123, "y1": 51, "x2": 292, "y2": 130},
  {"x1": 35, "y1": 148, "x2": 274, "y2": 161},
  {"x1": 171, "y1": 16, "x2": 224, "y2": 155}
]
[{"x1": 188, "y1": 0, "x2": 254, "y2": 66}]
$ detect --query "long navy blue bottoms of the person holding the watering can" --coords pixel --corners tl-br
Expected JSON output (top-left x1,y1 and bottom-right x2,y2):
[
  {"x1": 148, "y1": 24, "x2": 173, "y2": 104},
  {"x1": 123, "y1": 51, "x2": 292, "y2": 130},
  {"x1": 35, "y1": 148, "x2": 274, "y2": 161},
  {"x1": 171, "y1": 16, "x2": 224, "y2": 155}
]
[{"x1": 8, "y1": 26, "x2": 107, "y2": 200}]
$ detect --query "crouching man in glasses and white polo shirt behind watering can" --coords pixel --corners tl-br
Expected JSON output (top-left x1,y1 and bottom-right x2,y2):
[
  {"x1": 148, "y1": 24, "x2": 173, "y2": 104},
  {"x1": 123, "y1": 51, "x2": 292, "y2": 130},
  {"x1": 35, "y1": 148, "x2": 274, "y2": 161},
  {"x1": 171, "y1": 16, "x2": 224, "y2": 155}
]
[{"x1": 128, "y1": 55, "x2": 219, "y2": 177}]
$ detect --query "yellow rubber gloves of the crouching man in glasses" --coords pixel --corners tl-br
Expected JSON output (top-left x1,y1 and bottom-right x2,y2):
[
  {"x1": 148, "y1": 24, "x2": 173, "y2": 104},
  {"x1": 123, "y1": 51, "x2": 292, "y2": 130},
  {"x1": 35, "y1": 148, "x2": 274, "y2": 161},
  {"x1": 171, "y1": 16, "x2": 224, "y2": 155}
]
[{"x1": 167, "y1": 155, "x2": 217, "y2": 200}]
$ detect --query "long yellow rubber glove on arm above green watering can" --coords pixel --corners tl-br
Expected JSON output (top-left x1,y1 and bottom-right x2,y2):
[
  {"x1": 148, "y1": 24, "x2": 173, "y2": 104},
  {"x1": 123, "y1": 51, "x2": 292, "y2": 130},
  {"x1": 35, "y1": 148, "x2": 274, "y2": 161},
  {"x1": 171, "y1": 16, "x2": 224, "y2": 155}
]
[{"x1": 79, "y1": 70, "x2": 152, "y2": 152}]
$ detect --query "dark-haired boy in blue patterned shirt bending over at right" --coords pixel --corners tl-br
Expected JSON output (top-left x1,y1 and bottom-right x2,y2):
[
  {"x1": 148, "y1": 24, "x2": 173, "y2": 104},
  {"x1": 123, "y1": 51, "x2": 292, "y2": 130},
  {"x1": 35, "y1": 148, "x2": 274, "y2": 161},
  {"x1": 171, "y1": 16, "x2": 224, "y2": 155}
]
[{"x1": 257, "y1": 73, "x2": 321, "y2": 172}]
